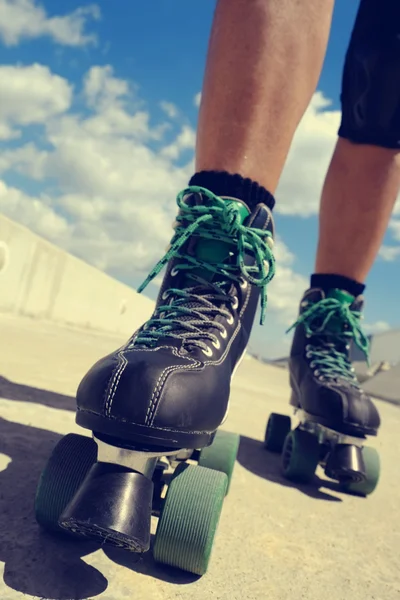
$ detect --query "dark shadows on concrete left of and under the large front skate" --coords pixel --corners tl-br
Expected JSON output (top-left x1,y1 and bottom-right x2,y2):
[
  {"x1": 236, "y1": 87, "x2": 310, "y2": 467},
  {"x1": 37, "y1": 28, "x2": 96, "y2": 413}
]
[{"x1": 0, "y1": 378, "x2": 196, "y2": 600}]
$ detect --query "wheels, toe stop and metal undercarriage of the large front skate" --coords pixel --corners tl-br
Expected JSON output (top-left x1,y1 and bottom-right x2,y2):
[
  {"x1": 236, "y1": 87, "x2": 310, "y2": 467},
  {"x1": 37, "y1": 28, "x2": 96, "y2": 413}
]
[{"x1": 35, "y1": 431, "x2": 239, "y2": 575}]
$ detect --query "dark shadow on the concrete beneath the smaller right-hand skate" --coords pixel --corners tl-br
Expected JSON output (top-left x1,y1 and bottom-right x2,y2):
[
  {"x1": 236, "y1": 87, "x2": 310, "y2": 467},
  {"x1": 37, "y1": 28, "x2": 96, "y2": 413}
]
[{"x1": 238, "y1": 436, "x2": 342, "y2": 502}]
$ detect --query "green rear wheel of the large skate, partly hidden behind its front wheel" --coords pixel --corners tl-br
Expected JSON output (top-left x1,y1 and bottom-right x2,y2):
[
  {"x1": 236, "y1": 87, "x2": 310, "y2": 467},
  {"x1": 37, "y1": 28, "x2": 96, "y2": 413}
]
[{"x1": 199, "y1": 431, "x2": 240, "y2": 493}]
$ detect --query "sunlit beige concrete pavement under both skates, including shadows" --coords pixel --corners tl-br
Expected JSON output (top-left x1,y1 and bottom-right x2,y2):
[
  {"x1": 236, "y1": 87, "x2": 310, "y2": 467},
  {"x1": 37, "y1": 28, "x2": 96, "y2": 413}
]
[{"x1": 0, "y1": 315, "x2": 400, "y2": 600}]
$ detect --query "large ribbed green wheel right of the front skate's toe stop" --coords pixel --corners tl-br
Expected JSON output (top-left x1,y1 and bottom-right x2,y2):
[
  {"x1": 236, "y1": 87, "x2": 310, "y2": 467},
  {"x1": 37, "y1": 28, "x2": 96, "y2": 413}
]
[{"x1": 153, "y1": 464, "x2": 228, "y2": 575}]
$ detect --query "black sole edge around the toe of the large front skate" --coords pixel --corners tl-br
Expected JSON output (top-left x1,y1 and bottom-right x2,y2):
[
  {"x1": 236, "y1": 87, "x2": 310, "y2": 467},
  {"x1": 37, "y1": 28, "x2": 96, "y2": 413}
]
[{"x1": 75, "y1": 409, "x2": 215, "y2": 450}]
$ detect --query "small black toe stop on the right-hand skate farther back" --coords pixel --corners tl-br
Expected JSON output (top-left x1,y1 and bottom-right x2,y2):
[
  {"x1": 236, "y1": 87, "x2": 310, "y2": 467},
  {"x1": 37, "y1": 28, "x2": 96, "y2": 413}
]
[{"x1": 325, "y1": 444, "x2": 367, "y2": 484}]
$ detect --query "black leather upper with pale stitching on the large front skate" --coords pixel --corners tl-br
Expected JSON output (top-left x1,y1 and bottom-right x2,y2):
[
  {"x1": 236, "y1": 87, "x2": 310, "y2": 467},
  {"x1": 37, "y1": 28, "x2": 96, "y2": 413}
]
[{"x1": 77, "y1": 198, "x2": 273, "y2": 432}]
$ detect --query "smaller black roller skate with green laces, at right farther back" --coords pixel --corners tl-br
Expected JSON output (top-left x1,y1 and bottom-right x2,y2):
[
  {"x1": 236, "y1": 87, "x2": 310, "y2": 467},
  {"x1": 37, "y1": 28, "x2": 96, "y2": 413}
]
[{"x1": 265, "y1": 289, "x2": 380, "y2": 495}]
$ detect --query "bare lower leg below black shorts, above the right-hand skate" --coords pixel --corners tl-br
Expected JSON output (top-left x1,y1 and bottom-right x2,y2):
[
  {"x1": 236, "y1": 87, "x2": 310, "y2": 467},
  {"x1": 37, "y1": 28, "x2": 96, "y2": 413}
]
[{"x1": 315, "y1": 139, "x2": 400, "y2": 283}]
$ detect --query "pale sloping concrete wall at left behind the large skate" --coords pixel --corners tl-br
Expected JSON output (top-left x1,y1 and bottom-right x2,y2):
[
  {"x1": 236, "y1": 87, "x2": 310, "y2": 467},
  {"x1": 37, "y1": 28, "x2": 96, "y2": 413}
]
[{"x1": 0, "y1": 215, "x2": 154, "y2": 335}]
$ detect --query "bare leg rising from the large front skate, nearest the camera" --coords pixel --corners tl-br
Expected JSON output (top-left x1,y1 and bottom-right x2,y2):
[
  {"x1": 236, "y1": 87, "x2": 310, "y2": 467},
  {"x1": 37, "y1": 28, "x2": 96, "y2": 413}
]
[{"x1": 196, "y1": 0, "x2": 334, "y2": 193}]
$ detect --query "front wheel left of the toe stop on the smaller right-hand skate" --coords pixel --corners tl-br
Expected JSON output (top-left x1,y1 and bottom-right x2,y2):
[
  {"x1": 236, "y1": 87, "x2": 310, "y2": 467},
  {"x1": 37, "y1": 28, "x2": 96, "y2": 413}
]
[{"x1": 282, "y1": 429, "x2": 319, "y2": 483}]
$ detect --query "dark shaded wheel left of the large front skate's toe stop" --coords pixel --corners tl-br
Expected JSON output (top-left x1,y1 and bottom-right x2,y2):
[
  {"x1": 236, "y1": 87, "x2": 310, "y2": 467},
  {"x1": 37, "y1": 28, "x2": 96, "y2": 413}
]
[{"x1": 35, "y1": 433, "x2": 97, "y2": 533}]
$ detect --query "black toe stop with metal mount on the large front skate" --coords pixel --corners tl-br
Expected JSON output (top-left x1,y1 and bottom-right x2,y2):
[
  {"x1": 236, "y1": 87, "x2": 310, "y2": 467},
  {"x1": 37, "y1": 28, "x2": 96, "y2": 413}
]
[{"x1": 59, "y1": 438, "x2": 160, "y2": 553}]
